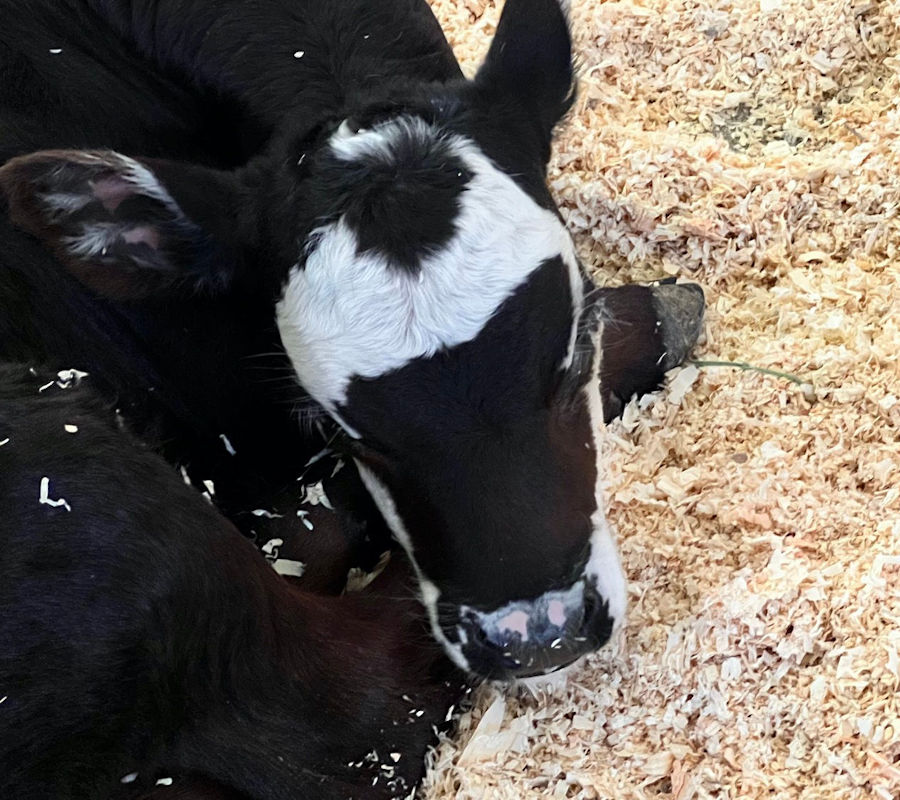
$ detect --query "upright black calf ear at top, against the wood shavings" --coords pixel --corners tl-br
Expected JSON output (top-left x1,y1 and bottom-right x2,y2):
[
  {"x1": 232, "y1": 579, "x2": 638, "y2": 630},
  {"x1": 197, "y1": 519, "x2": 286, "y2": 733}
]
[{"x1": 475, "y1": 0, "x2": 575, "y2": 147}]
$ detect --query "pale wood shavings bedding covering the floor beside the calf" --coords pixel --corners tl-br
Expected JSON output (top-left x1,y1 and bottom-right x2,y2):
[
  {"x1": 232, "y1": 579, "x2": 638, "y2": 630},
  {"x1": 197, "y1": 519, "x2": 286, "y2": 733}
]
[{"x1": 424, "y1": 0, "x2": 900, "y2": 800}]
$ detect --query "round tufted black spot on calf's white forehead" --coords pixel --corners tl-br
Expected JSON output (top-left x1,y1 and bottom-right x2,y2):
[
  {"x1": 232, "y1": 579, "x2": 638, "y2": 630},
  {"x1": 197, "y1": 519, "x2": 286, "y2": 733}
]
[{"x1": 316, "y1": 120, "x2": 471, "y2": 272}]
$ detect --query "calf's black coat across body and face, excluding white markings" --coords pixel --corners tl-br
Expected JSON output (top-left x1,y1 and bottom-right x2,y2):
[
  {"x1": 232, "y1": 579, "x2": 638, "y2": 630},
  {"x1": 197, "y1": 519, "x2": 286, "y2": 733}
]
[{"x1": 0, "y1": 0, "x2": 708, "y2": 800}]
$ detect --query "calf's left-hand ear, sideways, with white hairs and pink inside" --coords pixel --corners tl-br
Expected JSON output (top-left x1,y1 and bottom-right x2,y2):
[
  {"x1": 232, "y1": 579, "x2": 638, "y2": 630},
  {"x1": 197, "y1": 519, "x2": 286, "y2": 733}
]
[{"x1": 0, "y1": 150, "x2": 244, "y2": 299}]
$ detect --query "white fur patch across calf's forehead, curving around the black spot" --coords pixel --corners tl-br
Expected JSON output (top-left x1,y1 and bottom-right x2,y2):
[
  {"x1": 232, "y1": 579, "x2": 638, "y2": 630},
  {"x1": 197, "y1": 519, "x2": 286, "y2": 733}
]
[{"x1": 276, "y1": 120, "x2": 582, "y2": 414}]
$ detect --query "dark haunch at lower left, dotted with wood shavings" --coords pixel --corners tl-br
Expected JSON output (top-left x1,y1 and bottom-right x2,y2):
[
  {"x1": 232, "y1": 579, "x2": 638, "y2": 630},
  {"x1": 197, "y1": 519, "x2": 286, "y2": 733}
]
[{"x1": 0, "y1": 366, "x2": 459, "y2": 800}]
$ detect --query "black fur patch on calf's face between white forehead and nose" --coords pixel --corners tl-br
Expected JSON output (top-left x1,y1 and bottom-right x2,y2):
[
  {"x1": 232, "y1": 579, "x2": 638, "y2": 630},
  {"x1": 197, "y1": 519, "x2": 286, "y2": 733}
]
[{"x1": 341, "y1": 259, "x2": 596, "y2": 608}]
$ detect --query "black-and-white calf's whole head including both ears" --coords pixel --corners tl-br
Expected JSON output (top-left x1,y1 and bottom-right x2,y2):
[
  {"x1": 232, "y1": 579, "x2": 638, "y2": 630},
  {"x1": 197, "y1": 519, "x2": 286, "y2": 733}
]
[{"x1": 0, "y1": 0, "x2": 625, "y2": 678}]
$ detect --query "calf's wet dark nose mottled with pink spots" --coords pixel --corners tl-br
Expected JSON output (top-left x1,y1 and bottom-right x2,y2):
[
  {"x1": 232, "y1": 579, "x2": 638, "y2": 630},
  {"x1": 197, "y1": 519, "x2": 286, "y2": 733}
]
[{"x1": 448, "y1": 581, "x2": 614, "y2": 680}]
